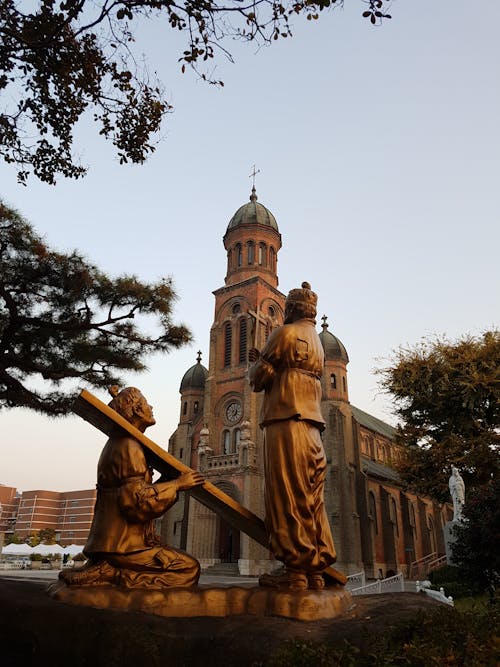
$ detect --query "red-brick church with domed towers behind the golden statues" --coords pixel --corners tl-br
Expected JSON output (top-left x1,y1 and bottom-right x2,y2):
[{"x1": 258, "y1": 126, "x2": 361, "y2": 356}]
[{"x1": 161, "y1": 188, "x2": 450, "y2": 578}]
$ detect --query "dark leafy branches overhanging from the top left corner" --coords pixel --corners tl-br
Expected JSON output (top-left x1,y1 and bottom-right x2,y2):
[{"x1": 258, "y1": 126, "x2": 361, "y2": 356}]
[{"x1": 0, "y1": 0, "x2": 390, "y2": 183}]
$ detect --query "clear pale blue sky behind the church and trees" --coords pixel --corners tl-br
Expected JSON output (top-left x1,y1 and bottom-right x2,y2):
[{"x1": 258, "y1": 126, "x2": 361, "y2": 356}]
[{"x1": 0, "y1": 0, "x2": 500, "y2": 491}]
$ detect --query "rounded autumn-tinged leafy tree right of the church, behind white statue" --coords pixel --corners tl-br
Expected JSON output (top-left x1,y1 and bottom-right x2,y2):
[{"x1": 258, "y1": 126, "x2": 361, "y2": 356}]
[{"x1": 378, "y1": 331, "x2": 500, "y2": 501}]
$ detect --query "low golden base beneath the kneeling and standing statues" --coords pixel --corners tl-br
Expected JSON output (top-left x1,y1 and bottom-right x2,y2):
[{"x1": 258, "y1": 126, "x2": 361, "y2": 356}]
[{"x1": 47, "y1": 582, "x2": 352, "y2": 621}]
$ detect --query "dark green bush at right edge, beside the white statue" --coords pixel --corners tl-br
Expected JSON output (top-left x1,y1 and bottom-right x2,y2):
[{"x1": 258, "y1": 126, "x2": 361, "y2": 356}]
[{"x1": 452, "y1": 475, "x2": 500, "y2": 599}]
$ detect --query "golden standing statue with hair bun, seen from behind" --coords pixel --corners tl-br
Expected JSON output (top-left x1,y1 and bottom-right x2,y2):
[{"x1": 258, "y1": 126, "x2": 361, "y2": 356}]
[{"x1": 248, "y1": 282, "x2": 335, "y2": 591}]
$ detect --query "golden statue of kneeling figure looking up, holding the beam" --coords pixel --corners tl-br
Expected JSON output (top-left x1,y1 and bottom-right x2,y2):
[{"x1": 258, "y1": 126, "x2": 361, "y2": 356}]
[{"x1": 59, "y1": 387, "x2": 204, "y2": 589}]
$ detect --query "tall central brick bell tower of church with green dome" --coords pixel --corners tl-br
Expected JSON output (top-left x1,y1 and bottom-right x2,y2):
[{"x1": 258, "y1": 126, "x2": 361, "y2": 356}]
[{"x1": 187, "y1": 186, "x2": 285, "y2": 574}]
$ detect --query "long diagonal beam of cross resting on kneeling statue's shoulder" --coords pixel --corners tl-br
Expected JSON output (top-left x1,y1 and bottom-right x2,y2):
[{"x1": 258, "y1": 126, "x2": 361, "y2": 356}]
[{"x1": 73, "y1": 390, "x2": 347, "y2": 585}]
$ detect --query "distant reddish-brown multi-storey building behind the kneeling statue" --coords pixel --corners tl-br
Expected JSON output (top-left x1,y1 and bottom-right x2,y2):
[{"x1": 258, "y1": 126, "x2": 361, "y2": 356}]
[{"x1": 0, "y1": 486, "x2": 96, "y2": 546}]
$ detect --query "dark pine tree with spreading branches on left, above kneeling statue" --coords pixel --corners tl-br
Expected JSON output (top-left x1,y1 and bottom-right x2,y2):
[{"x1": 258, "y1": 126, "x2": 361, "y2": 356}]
[{"x1": 0, "y1": 202, "x2": 190, "y2": 415}]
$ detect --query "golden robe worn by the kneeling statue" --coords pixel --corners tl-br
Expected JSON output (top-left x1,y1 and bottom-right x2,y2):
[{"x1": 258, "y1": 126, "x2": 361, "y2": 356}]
[{"x1": 84, "y1": 434, "x2": 200, "y2": 588}]
